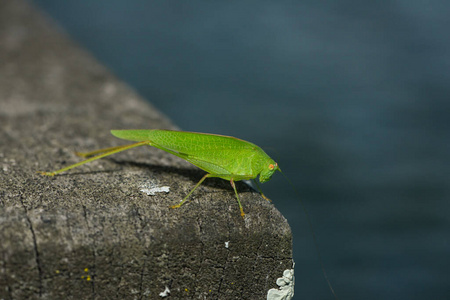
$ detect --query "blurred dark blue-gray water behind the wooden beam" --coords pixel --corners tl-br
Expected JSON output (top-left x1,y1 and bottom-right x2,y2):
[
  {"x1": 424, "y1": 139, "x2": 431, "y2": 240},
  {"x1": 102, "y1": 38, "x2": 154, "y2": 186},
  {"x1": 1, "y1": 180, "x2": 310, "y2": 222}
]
[{"x1": 34, "y1": 0, "x2": 450, "y2": 300}]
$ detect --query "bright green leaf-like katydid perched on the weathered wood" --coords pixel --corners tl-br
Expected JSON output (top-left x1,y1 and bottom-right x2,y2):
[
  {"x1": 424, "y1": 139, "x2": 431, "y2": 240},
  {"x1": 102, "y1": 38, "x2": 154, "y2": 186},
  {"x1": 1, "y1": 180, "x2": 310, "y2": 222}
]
[{"x1": 39, "y1": 129, "x2": 281, "y2": 217}]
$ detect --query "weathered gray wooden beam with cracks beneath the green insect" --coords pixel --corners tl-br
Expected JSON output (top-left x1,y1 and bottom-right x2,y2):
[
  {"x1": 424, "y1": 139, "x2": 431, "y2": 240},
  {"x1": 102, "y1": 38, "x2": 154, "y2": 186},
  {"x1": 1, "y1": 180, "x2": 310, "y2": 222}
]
[{"x1": 0, "y1": 0, "x2": 292, "y2": 299}]
